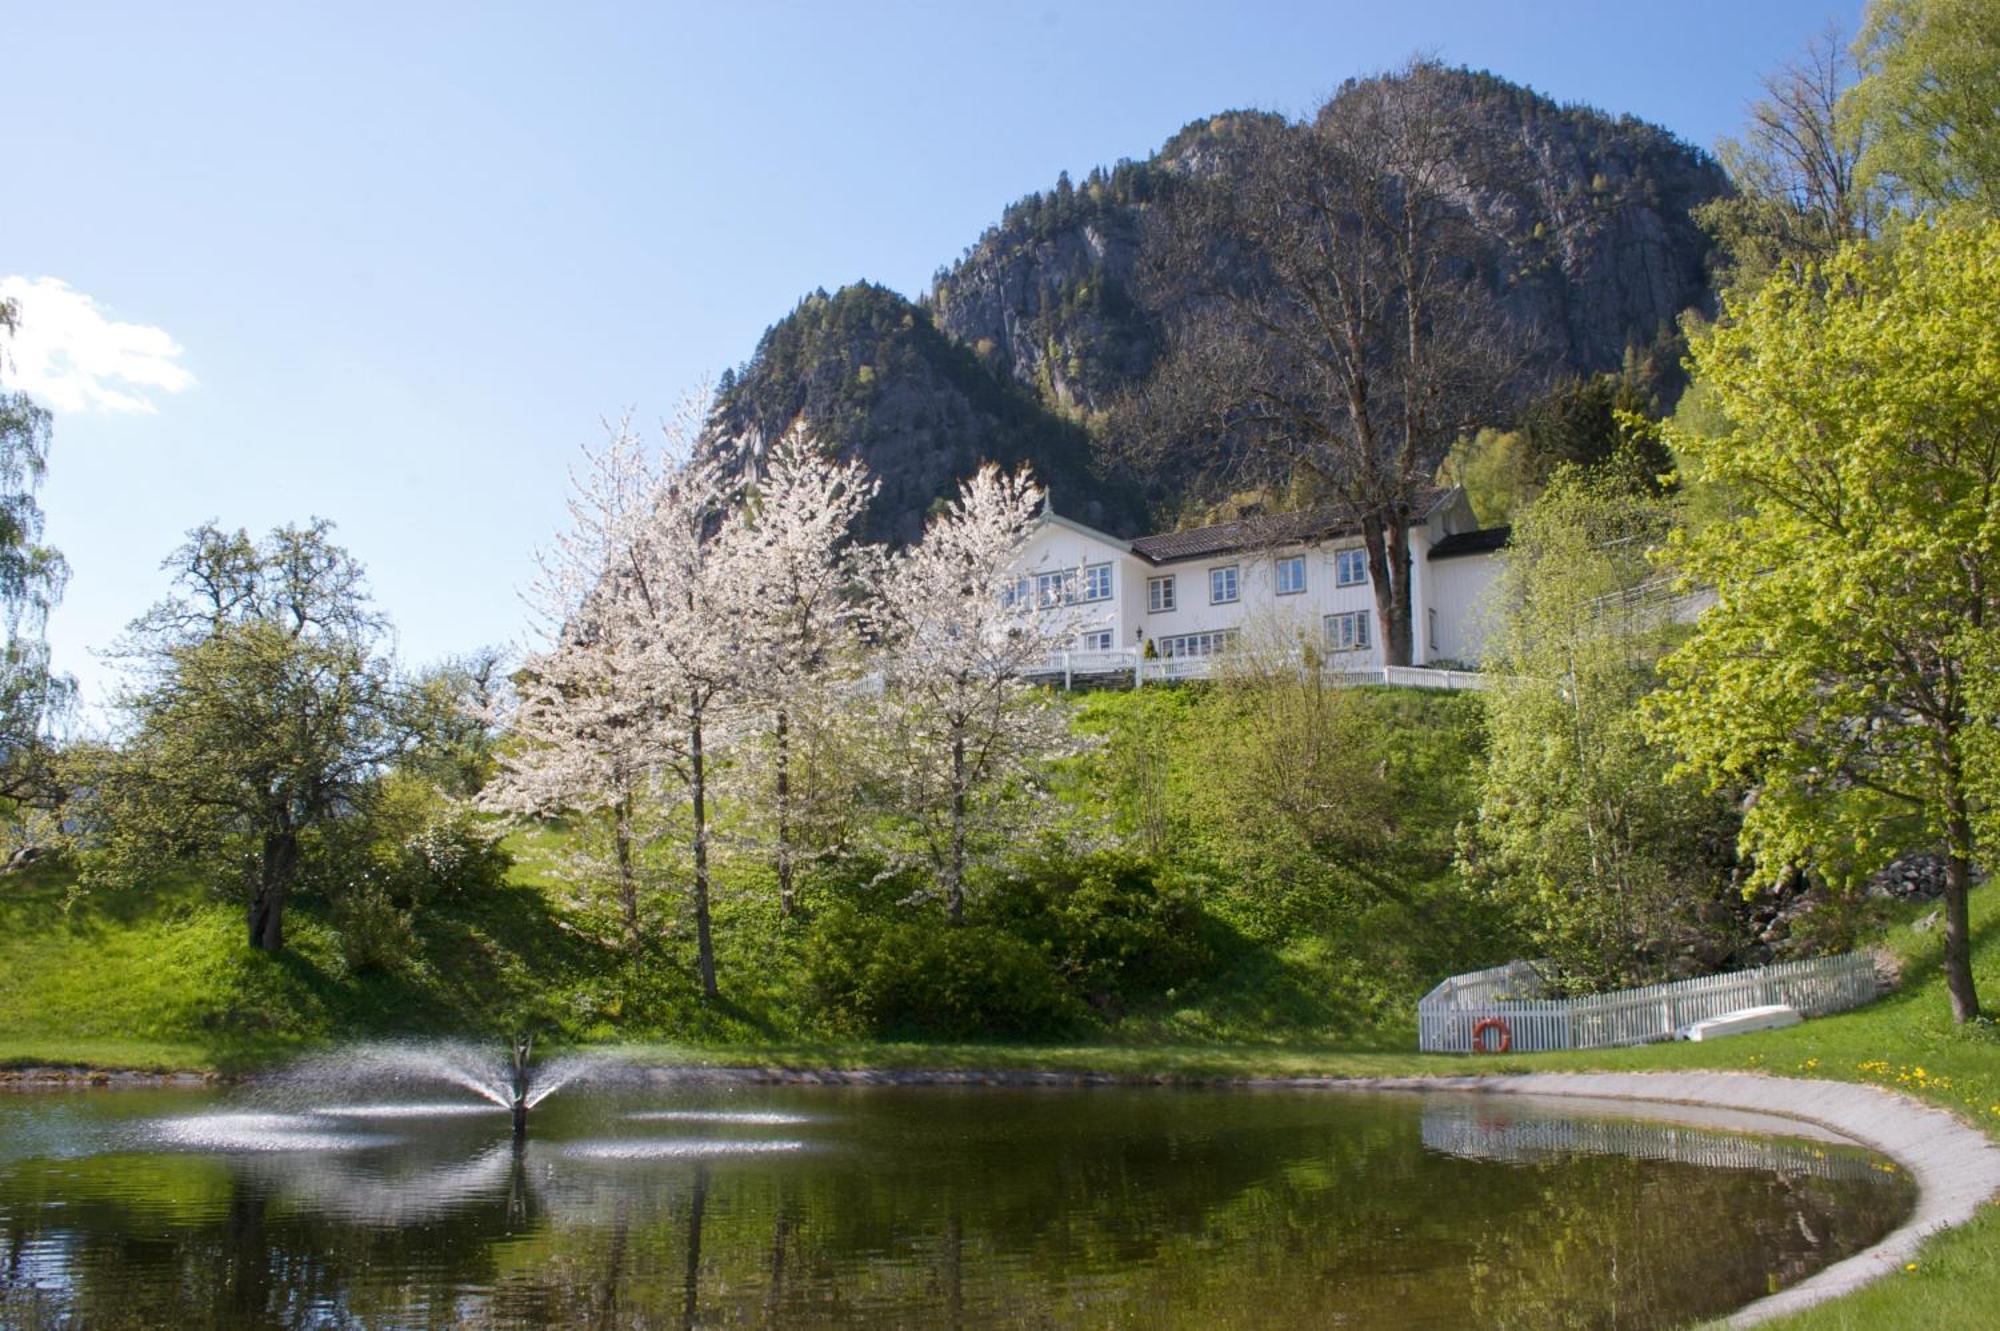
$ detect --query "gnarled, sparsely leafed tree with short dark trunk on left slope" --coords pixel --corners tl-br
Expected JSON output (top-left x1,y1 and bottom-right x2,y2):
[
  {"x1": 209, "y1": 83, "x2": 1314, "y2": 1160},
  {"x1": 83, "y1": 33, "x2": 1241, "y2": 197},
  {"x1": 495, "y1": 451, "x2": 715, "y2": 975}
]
[{"x1": 88, "y1": 520, "x2": 416, "y2": 951}]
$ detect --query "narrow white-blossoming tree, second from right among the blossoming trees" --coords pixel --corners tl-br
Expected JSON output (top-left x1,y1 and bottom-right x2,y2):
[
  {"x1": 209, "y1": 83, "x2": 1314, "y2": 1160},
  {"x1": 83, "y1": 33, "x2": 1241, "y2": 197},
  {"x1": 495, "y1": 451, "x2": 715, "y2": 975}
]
[{"x1": 734, "y1": 426, "x2": 878, "y2": 917}]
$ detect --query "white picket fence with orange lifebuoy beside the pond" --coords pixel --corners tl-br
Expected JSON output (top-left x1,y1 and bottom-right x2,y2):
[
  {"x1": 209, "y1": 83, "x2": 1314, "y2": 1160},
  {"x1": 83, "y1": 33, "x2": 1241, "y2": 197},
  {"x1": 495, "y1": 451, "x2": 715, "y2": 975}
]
[{"x1": 1416, "y1": 953, "x2": 1876, "y2": 1053}]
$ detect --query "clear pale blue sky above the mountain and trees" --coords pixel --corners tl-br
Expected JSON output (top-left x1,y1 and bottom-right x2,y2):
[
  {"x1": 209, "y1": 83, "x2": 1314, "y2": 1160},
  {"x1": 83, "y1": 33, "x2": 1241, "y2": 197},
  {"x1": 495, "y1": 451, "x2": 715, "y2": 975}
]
[{"x1": 11, "y1": 0, "x2": 1860, "y2": 715}]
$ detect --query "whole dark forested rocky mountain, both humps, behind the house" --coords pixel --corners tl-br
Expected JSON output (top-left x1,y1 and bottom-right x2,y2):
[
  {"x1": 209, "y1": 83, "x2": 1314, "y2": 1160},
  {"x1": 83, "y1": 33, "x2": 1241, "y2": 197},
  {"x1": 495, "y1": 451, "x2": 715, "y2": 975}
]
[{"x1": 720, "y1": 70, "x2": 1728, "y2": 540}]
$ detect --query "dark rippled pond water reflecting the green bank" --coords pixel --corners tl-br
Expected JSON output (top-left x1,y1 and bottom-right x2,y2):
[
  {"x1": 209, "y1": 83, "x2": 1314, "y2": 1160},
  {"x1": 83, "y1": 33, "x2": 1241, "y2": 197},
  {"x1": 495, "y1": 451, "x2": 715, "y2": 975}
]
[{"x1": 0, "y1": 1085, "x2": 1912, "y2": 1329}]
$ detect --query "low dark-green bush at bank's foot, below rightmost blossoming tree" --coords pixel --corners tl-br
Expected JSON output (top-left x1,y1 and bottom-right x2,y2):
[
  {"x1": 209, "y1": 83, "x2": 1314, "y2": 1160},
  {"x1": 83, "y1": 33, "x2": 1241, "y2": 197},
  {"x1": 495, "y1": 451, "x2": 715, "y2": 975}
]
[{"x1": 806, "y1": 903, "x2": 1086, "y2": 1039}]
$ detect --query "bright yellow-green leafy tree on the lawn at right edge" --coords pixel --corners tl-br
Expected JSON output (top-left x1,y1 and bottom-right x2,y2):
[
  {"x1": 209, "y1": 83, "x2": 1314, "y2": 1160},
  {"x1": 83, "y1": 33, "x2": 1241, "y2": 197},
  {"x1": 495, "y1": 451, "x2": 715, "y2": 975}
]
[{"x1": 1652, "y1": 222, "x2": 2000, "y2": 1021}]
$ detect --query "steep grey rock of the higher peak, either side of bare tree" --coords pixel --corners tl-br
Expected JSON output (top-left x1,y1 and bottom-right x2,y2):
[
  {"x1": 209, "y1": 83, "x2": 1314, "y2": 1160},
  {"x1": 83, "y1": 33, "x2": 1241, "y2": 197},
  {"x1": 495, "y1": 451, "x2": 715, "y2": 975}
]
[{"x1": 932, "y1": 72, "x2": 1728, "y2": 419}]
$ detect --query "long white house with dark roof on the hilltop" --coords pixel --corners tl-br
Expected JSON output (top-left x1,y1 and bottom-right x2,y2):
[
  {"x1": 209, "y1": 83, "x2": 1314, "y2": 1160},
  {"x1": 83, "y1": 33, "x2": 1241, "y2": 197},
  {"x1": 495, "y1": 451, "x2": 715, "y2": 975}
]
[{"x1": 1006, "y1": 488, "x2": 1508, "y2": 677}]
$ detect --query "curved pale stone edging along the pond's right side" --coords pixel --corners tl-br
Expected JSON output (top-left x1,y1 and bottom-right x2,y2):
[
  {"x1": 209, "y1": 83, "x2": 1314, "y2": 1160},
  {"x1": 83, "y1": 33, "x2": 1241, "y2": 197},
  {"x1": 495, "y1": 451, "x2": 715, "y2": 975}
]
[{"x1": 1312, "y1": 1071, "x2": 2000, "y2": 1327}]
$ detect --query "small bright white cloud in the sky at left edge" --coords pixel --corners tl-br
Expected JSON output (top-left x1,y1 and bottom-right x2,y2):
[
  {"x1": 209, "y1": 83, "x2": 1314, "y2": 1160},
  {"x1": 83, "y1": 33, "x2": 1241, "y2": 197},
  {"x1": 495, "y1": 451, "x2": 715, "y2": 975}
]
[{"x1": 0, "y1": 278, "x2": 194, "y2": 414}]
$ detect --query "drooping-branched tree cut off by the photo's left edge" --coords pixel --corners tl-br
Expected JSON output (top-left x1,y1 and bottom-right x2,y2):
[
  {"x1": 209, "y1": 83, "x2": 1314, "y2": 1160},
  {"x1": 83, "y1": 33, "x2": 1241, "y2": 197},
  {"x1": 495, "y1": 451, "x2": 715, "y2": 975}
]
[{"x1": 0, "y1": 300, "x2": 76, "y2": 823}]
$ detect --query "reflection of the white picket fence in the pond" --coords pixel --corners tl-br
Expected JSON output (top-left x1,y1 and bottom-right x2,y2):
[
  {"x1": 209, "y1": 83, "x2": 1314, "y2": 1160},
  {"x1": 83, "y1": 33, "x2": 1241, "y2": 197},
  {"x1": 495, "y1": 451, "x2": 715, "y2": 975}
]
[{"x1": 1422, "y1": 1105, "x2": 1878, "y2": 1179}]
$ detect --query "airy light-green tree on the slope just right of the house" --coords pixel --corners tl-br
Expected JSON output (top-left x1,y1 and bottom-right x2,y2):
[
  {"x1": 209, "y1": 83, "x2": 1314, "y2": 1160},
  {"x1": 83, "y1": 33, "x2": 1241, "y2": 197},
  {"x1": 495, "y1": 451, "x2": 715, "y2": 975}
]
[{"x1": 1464, "y1": 470, "x2": 1736, "y2": 987}]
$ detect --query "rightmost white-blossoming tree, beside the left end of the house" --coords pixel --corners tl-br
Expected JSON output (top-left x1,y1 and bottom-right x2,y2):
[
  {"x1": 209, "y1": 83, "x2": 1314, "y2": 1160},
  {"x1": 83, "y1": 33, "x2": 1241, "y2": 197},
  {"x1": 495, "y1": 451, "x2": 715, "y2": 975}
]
[{"x1": 876, "y1": 466, "x2": 1068, "y2": 923}]
